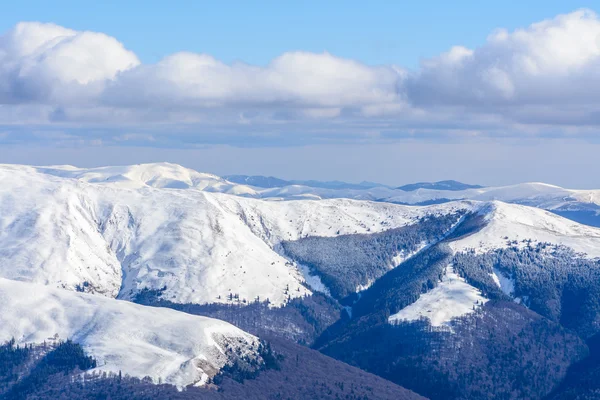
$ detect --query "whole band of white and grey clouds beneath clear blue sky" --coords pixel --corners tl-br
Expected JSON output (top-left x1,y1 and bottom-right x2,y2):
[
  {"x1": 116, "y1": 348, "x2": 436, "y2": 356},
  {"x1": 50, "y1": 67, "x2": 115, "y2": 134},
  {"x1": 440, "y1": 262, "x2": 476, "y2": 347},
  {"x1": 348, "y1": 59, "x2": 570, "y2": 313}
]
[{"x1": 0, "y1": 10, "x2": 600, "y2": 146}]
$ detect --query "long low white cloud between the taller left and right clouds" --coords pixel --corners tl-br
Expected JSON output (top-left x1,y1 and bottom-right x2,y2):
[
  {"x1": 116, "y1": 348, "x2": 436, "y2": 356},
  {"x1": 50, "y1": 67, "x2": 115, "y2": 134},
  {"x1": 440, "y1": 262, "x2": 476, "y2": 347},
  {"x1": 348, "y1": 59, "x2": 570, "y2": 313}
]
[{"x1": 104, "y1": 52, "x2": 402, "y2": 111}]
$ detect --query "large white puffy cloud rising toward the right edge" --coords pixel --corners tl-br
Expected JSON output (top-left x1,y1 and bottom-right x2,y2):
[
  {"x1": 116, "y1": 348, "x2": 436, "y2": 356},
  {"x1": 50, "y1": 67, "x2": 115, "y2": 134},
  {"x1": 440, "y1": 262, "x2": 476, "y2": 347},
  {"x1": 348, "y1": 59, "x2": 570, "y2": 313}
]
[{"x1": 406, "y1": 10, "x2": 600, "y2": 111}]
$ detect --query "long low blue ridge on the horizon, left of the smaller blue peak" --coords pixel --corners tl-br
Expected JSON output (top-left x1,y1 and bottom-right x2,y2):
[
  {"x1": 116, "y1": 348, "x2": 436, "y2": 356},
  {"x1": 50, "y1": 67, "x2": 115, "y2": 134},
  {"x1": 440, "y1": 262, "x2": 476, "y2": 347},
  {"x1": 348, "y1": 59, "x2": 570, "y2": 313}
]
[{"x1": 223, "y1": 175, "x2": 386, "y2": 189}]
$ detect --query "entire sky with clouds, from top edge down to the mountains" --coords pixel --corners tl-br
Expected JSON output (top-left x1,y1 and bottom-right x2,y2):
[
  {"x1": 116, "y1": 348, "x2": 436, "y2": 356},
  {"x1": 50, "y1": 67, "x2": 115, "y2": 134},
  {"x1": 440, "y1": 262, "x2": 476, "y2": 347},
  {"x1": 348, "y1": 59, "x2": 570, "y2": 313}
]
[{"x1": 0, "y1": 0, "x2": 600, "y2": 188}]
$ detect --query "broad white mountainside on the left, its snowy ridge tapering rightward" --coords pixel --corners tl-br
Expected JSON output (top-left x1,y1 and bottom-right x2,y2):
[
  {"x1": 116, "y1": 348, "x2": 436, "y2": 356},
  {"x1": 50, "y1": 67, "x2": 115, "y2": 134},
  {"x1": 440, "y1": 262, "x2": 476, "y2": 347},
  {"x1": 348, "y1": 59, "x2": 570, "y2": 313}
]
[{"x1": 0, "y1": 166, "x2": 474, "y2": 305}]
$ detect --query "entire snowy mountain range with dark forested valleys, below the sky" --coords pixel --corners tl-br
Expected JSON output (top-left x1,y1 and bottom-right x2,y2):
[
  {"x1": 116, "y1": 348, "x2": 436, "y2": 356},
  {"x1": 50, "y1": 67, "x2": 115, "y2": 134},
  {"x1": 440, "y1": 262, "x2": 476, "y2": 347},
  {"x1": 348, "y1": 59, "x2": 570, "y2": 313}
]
[{"x1": 0, "y1": 163, "x2": 600, "y2": 399}]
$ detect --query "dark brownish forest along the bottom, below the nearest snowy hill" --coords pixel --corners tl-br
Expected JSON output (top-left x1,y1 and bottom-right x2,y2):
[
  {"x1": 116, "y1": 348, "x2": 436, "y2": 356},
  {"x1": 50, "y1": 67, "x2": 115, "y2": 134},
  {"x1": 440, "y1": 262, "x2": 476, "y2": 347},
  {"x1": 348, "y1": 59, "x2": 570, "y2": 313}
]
[{"x1": 0, "y1": 338, "x2": 420, "y2": 400}]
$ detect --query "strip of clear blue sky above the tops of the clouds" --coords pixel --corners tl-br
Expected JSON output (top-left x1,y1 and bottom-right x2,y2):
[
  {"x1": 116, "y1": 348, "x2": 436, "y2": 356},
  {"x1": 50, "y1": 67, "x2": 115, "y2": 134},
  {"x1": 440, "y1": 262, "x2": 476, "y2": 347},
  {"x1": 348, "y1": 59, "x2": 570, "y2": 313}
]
[{"x1": 0, "y1": 0, "x2": 600, "y2": 67}]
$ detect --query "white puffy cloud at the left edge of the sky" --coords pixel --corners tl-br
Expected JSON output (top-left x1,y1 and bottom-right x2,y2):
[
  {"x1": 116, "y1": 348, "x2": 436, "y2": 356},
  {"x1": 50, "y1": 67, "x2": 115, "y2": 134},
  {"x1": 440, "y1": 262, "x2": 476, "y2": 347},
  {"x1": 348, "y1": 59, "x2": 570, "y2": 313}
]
[{"x1": 0, "y1": 22, "x2": 140, "y2": 103}]
